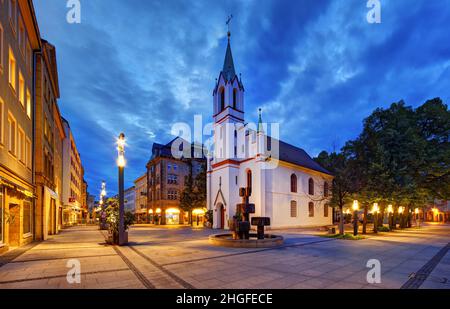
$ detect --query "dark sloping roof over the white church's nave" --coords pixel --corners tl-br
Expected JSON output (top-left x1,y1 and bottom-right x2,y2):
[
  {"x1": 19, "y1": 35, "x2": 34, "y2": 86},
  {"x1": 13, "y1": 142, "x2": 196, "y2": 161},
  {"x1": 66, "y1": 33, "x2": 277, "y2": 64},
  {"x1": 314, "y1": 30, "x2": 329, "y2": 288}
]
[{"x1": 268, "y1": 137, "x2": 333, "y2": 175}]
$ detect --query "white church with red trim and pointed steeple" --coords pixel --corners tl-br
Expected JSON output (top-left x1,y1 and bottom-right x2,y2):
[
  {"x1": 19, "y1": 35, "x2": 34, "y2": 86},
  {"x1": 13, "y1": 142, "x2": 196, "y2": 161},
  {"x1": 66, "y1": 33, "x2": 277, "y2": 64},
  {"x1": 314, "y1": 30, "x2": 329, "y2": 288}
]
[{"x1": 207, "y1": 34, "x2": 333, "y2": 229}]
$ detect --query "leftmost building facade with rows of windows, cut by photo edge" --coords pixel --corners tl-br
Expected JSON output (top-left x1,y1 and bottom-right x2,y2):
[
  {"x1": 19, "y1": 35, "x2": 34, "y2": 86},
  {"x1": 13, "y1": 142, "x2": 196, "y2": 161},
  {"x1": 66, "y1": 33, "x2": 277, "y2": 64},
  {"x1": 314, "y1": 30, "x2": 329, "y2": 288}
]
[{"x1": 0, "y1": 0, "x2": 41, "y2": 252}]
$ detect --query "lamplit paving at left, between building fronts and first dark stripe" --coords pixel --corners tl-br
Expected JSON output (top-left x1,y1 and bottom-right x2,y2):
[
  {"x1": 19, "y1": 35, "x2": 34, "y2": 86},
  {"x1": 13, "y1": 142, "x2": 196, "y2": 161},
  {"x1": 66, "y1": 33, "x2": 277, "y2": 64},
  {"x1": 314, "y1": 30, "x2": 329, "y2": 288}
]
[{"x1": 0, "y1": 226, "x2": 144, "y2": 289}]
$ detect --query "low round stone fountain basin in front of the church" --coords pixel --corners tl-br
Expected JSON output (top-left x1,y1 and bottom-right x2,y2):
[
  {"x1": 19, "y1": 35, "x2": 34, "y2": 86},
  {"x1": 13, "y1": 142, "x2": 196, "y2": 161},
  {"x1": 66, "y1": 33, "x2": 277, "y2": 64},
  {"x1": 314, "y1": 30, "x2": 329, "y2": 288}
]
[{"x1": 209, "y1": 233, "x2": 284, "y2": 248}]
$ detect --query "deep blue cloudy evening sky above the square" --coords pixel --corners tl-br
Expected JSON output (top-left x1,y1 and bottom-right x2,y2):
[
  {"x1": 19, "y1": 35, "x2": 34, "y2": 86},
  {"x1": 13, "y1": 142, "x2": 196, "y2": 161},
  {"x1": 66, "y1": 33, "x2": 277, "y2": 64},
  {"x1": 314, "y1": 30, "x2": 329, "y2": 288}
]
[{"x1": 34, "y1": 0, "x2": 450, "y2": 195}]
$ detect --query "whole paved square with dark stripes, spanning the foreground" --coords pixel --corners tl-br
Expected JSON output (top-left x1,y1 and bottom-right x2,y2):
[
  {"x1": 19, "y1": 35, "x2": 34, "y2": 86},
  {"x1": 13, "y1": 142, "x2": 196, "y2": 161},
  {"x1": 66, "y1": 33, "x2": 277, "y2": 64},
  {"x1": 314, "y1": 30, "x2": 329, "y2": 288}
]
[{"x1": 0, "y1": 225, "x2": 450, "y2": 289}]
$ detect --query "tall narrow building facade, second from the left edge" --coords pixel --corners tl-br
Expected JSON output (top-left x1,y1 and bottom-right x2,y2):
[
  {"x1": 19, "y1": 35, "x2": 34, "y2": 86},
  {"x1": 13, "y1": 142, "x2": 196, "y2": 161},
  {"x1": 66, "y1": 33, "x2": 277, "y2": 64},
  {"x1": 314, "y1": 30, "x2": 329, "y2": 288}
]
[{"x1": 34, "y1": 40, "x2": 60, "y2": 240}]
